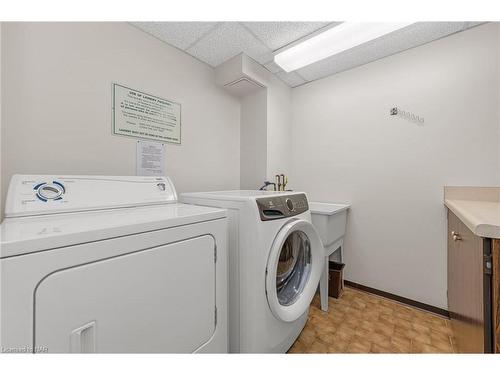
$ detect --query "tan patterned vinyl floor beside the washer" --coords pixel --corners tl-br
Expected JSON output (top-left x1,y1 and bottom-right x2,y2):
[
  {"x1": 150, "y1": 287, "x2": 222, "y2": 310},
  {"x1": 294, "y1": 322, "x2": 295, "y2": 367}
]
[{"x1": 288, "y1": 288, "x2": 454, "y2": 353}]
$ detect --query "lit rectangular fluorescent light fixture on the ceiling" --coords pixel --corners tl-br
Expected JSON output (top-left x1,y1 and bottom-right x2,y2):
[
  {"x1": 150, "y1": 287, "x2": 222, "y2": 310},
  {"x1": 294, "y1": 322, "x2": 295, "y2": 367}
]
[{"x1": 274, "y1": 22, "x2": 413, "y2": 72}]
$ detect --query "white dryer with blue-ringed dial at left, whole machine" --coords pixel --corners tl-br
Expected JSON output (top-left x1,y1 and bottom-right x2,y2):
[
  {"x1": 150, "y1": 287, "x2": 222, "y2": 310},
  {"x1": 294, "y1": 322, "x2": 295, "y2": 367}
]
[{"x1": 0, "y1": 175, "x2": 227, "y2": 353}]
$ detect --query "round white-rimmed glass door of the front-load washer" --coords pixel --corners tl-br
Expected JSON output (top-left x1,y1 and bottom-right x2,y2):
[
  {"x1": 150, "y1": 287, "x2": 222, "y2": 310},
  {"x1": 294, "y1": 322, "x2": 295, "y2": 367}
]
[{"x1": 266, "y1": 220, "x2": 325, "y2": 322}]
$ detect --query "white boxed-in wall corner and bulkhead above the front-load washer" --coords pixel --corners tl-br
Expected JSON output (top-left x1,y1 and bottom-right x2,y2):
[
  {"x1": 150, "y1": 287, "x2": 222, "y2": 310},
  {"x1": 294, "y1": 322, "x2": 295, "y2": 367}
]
[{"x1": 215, "y1": 54, "x2": 291, "y2": 189}]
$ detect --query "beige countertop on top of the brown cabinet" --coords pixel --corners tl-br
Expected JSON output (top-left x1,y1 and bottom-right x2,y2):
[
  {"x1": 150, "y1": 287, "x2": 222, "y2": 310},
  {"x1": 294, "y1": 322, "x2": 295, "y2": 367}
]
[{"x1": 444, "y1": 187, "x2": 500, "y2": 239}]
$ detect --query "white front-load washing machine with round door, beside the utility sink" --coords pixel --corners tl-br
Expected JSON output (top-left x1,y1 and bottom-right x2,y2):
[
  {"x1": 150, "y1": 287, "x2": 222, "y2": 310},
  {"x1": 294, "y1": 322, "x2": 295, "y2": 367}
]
[{"x1": 181, "y1": 190, "x2": 324, "y2": 353}]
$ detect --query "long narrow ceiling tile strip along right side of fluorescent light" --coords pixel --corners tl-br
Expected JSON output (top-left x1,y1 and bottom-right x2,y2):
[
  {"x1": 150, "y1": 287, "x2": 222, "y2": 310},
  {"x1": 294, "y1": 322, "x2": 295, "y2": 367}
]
[{"x1": 297, "y1": 22, "x2": 482, "y2": 81}]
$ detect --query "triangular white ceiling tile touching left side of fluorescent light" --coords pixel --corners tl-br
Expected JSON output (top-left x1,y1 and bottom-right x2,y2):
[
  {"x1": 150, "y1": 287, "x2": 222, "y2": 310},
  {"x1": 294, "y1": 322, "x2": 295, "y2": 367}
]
[{"x1": 243, "y1": 22, "x2": 331, "y2": 51}]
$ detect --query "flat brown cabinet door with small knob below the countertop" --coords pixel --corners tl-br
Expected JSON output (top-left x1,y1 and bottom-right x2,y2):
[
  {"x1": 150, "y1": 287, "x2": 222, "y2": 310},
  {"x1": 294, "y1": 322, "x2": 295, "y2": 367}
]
[{"x1": 448, "y1": 213, "x2": 484, "y2": 353}]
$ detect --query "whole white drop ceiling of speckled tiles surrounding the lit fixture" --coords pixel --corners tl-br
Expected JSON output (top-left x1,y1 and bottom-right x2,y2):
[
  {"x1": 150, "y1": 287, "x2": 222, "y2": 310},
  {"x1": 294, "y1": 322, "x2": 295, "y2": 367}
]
[{"x1": 132, "y1": 22, "x2": 480, "y2": 87}]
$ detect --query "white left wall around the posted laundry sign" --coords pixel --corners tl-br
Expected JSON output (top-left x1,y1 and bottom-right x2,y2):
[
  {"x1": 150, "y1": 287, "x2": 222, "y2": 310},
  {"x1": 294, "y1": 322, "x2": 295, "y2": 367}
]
[{"x1": 1, "y1": 23, "x2": 240, "y2": 211}]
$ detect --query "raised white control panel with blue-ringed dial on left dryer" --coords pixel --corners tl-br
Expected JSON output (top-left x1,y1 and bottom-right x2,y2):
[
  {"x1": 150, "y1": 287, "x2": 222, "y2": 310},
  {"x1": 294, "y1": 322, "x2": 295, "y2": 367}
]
[{"x1": 5, "y1": 175, "x2": 177, "y2": 217}]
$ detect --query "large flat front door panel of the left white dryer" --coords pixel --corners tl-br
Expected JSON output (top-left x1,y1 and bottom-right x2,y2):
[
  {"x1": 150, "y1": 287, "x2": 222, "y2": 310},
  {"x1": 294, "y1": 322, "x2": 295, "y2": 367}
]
[{"x1": 34, "y1": 235, "x2": 216, "y2": 353}]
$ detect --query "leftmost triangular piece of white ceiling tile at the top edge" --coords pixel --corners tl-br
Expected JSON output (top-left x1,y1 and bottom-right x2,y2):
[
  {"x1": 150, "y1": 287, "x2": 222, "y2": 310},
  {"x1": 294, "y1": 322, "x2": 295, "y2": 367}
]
[{"x1": 132, "y1": 22, "x2": 217, "y2": 50}]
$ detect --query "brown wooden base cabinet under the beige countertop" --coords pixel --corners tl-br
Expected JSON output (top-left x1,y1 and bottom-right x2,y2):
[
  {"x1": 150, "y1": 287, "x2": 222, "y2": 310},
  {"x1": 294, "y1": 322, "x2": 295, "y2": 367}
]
[{"x1": 448, "y1": 211, "x2": 500, "y2": 353}]
